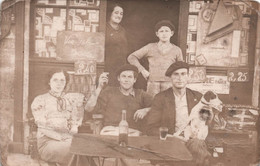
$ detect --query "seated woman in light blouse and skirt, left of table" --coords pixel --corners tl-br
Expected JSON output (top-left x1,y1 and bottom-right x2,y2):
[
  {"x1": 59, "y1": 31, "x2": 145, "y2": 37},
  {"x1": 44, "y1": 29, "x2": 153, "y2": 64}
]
[{"x1": 31, "y1": 70, "x2": 93, "y2": 165}]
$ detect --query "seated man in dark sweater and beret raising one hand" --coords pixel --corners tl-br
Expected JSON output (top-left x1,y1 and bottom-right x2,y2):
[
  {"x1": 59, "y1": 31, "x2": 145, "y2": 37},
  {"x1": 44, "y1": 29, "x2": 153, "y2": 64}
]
[{"x1": 85, "y1": 64, "x2": 152, "y2": 135}]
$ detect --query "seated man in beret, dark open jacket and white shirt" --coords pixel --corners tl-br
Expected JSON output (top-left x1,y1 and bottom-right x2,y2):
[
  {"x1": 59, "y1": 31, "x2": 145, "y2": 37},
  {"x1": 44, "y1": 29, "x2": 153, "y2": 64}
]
[{"x1": 147, "y1": 61, "x2": 202, "y2": 135}]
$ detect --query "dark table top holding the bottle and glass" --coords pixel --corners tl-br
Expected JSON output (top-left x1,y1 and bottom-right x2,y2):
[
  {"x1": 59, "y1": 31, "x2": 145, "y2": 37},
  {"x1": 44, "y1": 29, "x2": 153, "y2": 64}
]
[{"x1": 70, "y1": 133, "x2": 192, "y2": 161}]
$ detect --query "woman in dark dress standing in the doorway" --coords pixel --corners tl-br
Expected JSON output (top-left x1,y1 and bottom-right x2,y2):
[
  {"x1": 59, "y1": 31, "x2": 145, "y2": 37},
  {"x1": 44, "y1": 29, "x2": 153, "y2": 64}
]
[{"x1": 105, "y1": 4, "x2": 128, "y2": 86}]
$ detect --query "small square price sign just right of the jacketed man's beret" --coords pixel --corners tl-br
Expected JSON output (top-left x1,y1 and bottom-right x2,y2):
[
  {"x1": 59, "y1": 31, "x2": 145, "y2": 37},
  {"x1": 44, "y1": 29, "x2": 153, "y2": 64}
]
[{"x1": 189, "y1": 67, "x2": 206, "y2": 83}]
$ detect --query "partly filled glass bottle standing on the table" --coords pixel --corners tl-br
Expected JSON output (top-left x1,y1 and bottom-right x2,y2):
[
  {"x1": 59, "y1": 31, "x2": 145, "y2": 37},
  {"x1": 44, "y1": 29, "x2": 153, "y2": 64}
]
[{"x1": 119, "y1": 110, "x2": 128, "y2": 146}]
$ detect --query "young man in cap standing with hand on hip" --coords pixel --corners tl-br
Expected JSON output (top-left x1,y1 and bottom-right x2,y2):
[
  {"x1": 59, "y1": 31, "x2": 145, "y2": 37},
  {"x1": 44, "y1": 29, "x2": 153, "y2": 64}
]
[{"x1": 127, "y1": 20, "x2": 183, "y2": 96}]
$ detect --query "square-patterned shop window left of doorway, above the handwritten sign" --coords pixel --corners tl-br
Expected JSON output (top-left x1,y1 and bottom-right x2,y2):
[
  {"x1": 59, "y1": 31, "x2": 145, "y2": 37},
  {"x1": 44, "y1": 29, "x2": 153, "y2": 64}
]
[{"x1": 31, "y1": 0, "x2": 101, "y2": 59}]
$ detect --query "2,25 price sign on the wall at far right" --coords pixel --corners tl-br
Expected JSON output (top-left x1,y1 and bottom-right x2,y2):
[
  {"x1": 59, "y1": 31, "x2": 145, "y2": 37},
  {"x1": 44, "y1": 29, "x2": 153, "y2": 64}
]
[{"x1": 228, "y1": 69, "x2": 249, "y2": 82}]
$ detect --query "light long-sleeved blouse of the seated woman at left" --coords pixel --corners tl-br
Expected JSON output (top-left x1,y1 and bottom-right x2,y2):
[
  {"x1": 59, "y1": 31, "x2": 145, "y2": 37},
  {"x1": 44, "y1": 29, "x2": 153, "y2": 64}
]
[{"x1": 31, "y1": 93, "x2": 84, "y2": 139}]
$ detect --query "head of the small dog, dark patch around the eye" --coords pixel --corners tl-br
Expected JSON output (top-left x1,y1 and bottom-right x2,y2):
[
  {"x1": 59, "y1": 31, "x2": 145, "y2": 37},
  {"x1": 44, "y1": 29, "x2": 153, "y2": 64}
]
[{"x1": 201, "y1": 91, "x2": 223, "y2": 112}]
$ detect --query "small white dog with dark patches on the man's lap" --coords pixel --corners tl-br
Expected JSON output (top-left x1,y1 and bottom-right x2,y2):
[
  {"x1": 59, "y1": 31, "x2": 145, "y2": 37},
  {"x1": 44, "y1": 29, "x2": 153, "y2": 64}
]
[{"x1": 174, "y1": 91, "x2": 222, "y2": 140}]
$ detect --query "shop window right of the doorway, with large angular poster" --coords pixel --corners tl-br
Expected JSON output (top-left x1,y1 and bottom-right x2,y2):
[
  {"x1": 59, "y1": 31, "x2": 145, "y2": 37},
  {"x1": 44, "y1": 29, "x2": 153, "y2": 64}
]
[{"x1": 186, "y1": 1, "x2": 252, "y2": 67}]
